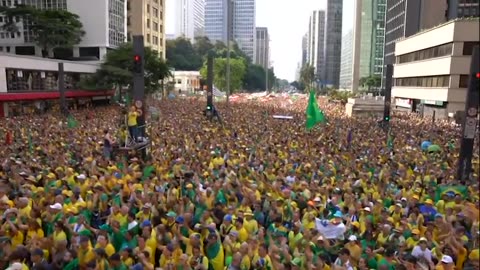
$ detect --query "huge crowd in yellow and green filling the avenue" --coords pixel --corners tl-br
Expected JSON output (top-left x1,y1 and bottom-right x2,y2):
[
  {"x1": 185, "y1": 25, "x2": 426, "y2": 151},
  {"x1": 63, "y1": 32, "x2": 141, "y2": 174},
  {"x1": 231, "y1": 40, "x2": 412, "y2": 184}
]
[{"x1": 0, "y1": 98, "x2": 480, "y2": 270}]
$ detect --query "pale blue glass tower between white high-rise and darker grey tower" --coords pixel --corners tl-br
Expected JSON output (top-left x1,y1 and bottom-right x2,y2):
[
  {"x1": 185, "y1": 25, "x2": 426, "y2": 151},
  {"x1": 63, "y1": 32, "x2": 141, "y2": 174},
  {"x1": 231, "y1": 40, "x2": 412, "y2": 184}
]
[{"x1": 205, "y1": 0, "x2": 233, "y2": 43}]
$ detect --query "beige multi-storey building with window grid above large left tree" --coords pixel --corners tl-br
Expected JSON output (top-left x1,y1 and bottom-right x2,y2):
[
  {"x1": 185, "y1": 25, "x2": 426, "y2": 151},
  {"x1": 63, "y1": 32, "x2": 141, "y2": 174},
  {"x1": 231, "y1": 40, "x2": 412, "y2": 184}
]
[{"x1": 127, "y1": 0, "x2": 165, "y2": 59}]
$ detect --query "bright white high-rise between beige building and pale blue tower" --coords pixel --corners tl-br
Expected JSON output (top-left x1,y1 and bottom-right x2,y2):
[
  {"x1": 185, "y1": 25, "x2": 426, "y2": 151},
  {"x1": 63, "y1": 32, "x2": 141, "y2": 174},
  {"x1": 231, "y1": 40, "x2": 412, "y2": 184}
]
[{"x1": 167, "y1": 0, "x2": 205, "y2": 42}]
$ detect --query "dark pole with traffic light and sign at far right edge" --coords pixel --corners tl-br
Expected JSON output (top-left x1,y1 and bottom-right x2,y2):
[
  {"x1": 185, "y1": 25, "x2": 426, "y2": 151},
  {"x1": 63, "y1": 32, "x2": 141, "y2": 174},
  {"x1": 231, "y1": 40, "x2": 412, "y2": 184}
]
[{"x1": 457, "y1": 46, "x2": 480, "y2": 185}]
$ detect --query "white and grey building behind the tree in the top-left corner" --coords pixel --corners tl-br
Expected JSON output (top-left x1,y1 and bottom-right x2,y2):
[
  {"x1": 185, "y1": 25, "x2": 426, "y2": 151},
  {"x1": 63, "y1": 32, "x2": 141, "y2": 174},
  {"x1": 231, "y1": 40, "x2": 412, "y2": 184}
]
[{"x1": 0, "y1": 0, "x2": 127, "y2": 59}]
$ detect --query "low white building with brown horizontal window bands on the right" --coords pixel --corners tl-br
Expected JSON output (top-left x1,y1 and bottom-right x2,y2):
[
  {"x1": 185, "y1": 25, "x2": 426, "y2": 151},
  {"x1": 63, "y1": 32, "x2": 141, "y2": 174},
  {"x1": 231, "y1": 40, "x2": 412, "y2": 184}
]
[{"x1": 392, "y1": 19, "x2": 480, "y2": 118}]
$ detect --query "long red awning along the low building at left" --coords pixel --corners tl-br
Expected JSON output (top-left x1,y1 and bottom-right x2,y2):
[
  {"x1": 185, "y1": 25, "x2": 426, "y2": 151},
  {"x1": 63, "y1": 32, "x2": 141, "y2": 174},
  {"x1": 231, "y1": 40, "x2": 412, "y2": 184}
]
[{"x1": 0, "y1": 90, "x2": 115, "y2": 102}]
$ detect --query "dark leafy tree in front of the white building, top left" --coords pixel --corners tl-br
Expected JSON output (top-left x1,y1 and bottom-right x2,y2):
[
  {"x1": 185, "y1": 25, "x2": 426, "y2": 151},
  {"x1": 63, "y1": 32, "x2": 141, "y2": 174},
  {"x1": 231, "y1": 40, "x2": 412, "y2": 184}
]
[{"x1": 0, "y1": 6, "x2": 85, "y2": 57}]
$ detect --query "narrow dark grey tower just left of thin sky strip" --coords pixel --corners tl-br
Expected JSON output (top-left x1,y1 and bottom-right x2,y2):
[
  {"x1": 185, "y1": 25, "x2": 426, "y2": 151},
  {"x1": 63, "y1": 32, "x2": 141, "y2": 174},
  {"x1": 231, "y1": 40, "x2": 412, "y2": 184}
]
[{"x1": 323, "y1": 0, "x2": 343, "y2": 88}]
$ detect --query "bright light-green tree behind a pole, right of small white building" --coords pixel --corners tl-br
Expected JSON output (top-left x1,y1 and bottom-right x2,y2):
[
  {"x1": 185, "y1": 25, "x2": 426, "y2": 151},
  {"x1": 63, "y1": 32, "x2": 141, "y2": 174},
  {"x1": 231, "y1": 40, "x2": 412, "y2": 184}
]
[{"x1": 200, "y1": 58, "x2": 246, "y2": 92}]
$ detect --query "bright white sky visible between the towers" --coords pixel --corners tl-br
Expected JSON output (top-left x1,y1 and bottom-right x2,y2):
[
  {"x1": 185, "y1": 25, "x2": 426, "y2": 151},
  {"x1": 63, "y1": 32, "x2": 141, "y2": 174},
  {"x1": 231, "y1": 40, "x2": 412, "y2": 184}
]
[{"x1": 165, "y1": 0, "x2": 355, "y2": 81}]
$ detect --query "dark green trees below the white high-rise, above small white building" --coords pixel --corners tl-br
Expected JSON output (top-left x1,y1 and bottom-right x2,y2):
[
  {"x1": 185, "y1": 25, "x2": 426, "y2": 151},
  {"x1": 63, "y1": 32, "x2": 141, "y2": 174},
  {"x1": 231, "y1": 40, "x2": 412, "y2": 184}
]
[{"x1": 166, "y1": 37, "x2": 203, "y2": 70}]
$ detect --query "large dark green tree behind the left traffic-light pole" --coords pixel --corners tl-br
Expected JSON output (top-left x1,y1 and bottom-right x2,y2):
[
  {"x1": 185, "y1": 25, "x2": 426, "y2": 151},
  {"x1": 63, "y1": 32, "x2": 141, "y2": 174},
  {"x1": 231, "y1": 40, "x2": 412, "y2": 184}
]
[{"x1": 85, "y1": 43, "x2": 171, "y2": 93}]
